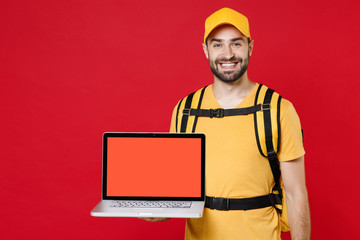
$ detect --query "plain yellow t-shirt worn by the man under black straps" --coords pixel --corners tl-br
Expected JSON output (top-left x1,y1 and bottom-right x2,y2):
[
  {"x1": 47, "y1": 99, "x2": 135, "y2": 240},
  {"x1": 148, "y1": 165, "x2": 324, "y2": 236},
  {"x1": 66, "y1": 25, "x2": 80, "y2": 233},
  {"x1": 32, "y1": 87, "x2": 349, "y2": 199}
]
[{"x1": 170, "y1": 84, "x2": 305, "y2": 240}]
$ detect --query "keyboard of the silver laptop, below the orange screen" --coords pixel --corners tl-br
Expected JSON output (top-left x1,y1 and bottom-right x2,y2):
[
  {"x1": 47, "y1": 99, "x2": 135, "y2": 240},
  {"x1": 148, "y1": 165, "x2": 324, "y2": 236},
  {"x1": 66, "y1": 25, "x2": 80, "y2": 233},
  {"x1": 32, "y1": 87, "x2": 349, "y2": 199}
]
[{"x1": 109, "y1": 201, "x2": 191, "y2": 208}]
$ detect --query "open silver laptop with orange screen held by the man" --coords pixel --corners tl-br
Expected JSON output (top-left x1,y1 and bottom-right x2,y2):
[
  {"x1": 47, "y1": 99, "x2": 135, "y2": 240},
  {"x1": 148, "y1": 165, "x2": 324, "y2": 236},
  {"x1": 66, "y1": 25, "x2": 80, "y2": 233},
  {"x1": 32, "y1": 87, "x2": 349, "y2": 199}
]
[{"x1": 91, "y1": 132, "x2": 205, "y2": 218}]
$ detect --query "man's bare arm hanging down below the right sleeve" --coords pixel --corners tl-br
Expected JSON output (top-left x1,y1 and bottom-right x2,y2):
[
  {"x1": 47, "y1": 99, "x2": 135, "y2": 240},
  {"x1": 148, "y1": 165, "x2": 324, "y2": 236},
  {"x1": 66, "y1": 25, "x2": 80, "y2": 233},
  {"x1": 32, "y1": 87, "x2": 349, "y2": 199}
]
[{"x1": 280, "y1": 156, "x2": 311, "y2": 240}]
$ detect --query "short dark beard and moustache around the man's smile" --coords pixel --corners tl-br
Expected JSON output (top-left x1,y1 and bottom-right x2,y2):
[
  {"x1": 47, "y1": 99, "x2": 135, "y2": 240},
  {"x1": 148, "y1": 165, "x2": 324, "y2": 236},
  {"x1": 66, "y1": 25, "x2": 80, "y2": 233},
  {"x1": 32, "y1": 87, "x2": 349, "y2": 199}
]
[{"x1": 209, "y1": 54, "x2": 250, "y2": 83}]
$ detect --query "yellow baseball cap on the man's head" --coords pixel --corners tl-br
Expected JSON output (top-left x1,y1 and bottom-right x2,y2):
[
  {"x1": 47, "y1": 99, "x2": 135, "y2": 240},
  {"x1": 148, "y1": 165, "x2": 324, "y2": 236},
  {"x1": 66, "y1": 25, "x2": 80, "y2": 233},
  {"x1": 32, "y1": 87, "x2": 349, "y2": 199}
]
[{"x1": 204, "y1": 8, "x2": 251, "y2": 44}]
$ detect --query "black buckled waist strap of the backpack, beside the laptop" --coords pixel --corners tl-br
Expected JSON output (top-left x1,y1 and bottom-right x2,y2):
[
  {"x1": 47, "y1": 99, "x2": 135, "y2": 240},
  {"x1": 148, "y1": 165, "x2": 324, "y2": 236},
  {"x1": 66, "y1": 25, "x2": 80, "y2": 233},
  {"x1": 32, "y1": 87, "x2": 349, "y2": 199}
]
[{"x1": 205, "y1": 193, "x2": 281, "y2": 211}]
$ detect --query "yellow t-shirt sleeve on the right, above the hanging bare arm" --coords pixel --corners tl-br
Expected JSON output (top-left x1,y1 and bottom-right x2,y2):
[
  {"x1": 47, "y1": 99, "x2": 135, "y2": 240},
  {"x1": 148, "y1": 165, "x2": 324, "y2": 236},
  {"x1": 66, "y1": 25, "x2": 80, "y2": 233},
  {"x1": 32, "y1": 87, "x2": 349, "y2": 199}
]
[{"x1": 278, "y1": 99, "x2": 305, "y2": 162}]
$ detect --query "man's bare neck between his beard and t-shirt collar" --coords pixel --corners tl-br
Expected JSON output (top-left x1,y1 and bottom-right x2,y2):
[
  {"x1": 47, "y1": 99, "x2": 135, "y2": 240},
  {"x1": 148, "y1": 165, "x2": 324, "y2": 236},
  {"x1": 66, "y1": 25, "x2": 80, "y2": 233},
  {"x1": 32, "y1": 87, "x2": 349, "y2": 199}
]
[{"x1": 213, "y1": 72, "x2": 255, "y2": 108}]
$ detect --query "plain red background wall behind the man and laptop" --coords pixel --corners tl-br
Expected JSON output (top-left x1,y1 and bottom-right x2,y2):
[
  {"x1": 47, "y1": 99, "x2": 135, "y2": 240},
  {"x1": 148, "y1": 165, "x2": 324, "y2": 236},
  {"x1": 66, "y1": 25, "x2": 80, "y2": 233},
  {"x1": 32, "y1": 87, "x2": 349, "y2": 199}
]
[{"x1": 0, "y1": 0, "x2": 360, "y2": 239}]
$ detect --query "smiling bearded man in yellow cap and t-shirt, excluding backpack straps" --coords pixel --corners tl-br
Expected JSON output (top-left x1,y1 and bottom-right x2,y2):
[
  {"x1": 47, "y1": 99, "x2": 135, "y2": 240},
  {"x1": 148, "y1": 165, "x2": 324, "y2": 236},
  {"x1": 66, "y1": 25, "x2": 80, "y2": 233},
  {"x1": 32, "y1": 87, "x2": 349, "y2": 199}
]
[{"x1": 147, "y1": 8, "x2": 310, "y2": 240}]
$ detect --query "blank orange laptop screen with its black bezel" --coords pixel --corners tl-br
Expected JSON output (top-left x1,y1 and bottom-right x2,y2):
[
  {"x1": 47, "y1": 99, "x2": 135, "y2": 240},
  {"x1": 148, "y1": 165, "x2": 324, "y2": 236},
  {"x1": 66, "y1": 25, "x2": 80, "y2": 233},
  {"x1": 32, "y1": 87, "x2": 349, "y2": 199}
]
[{"x1": 103, "y1": 133, "x2": 204, "y2": 198}]
